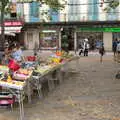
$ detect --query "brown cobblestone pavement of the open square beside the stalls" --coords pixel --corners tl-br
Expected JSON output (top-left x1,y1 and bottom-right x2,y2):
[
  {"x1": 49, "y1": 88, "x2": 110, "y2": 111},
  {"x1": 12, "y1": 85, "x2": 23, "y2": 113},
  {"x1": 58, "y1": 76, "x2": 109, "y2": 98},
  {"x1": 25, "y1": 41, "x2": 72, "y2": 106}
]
[{"x1": 0, "y1": 55, "x2": 120, "y2": 120}]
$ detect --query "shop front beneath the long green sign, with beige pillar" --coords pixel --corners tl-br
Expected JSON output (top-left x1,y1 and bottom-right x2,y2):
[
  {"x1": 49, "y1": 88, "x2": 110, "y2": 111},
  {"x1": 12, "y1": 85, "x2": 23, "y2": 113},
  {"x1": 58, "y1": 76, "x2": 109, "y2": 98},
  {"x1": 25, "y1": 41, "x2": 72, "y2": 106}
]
[{"x1": 76, "y1": 27, "x2": 120, "y2": 51}]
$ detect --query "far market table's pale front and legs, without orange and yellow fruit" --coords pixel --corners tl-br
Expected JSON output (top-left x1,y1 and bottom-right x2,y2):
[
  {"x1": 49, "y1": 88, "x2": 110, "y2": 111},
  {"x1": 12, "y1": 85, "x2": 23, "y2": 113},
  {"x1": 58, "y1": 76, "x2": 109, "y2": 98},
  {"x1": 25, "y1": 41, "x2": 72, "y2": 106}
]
[{"x1": 34, "y1": 56, "x2": 79, "y2": 90}]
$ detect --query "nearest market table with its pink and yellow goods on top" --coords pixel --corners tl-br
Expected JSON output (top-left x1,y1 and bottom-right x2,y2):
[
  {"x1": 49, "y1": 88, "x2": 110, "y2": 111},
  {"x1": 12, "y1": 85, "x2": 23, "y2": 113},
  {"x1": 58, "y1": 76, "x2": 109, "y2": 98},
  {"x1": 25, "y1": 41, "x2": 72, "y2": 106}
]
[{"x1": 0, "y1": 65, "x2": 32, "y2": 120}]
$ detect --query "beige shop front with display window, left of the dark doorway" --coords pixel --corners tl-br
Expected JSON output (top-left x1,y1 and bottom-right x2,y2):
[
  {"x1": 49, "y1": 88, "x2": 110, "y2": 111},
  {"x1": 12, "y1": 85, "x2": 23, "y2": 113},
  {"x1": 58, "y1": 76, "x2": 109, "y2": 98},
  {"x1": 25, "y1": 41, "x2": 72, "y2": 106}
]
[{"x1": 24, "y1": 28, "x2": 60, "y2": 50}]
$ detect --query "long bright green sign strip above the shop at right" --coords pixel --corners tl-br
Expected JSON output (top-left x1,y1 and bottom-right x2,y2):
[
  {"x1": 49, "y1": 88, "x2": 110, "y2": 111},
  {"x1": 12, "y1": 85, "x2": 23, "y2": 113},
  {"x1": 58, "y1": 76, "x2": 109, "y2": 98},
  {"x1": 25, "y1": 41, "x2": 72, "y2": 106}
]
[{"x1": 77, "y1": 27, "x2": 120, "y2": 32}]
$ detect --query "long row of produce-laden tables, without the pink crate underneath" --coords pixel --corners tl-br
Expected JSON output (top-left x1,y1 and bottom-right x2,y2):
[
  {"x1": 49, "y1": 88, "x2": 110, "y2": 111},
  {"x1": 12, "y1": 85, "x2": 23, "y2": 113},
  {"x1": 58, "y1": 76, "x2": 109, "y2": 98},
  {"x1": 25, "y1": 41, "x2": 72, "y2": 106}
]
[{"x1": 0, "y1": 51, "x2": 77, "y2": 120}]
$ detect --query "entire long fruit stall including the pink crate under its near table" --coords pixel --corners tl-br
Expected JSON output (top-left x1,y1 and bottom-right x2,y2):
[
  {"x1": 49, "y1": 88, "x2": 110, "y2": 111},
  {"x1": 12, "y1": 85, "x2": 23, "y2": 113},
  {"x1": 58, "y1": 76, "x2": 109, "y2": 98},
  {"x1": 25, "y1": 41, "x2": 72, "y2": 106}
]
[{"x1": 0, "y1": 51, "x2": 78, "y2": 120}]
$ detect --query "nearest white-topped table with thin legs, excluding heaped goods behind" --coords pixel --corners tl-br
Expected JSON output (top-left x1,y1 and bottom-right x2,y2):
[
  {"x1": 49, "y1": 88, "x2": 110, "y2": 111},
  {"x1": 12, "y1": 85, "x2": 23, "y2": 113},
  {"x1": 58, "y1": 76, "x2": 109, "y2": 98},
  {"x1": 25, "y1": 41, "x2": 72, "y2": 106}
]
[{"x1": 0, "y1": 71, "x2": 32, "y2": 120}]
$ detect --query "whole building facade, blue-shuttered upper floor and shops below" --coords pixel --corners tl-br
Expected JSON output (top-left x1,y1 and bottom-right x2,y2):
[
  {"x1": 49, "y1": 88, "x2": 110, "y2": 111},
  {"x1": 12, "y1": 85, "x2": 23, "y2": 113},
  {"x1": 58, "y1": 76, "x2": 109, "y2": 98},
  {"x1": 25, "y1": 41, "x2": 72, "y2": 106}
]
[{"x1": 2, "y1": 0, "x2": 120, "y2": 51}]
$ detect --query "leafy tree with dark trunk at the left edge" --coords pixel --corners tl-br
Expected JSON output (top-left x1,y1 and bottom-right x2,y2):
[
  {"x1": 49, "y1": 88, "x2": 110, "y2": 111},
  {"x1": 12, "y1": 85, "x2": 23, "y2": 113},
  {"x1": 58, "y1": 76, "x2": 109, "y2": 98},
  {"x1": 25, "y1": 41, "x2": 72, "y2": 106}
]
[{"x1": 0, "y1": 0, "x2": 64, "y2": 50}]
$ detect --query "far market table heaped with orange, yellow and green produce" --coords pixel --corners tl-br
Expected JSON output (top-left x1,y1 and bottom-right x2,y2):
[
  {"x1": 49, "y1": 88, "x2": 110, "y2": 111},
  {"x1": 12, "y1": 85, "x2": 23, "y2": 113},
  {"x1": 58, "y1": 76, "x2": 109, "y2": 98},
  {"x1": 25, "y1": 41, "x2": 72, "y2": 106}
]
[{"x1": 33, "y1": 51, "x2": 78, "y2": 92}]
